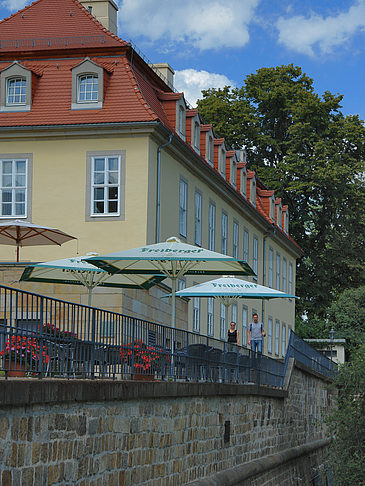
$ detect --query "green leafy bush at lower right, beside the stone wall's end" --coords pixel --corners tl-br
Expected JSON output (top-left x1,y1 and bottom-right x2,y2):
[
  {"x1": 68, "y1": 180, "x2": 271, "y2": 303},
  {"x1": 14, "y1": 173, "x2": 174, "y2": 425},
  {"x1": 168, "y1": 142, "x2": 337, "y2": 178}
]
[{"x1": 327, "y1": 343, "x2": 365, "y2": 486}]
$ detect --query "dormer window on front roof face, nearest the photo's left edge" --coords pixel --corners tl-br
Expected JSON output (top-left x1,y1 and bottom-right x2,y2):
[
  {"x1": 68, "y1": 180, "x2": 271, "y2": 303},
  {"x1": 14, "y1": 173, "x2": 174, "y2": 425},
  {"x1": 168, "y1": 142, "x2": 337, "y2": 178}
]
[{"x1": 0, "y1": 62, "x2": 32, "y2": 112}]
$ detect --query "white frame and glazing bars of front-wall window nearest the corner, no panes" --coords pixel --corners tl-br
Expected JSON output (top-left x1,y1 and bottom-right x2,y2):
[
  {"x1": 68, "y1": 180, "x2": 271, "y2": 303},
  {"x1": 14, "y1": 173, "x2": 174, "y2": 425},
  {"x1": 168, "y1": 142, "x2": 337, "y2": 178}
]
[{"x1": 90, "y1": 154, "x2": 121, "y2": 218}]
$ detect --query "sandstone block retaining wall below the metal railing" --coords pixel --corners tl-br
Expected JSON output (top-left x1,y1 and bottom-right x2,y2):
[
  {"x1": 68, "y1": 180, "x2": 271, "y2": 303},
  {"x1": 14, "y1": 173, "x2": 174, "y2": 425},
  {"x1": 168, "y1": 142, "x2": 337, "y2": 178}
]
[{"x1": 0, "y1": 367, "x2": 332, "y2": 486}]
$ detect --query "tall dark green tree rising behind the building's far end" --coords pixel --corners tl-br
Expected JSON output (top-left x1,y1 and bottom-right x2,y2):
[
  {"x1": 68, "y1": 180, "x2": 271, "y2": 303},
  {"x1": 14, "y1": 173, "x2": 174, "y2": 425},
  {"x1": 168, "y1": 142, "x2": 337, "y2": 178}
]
[{"x1": 198, "y1": 64, "x2": 365, "y2": 318}]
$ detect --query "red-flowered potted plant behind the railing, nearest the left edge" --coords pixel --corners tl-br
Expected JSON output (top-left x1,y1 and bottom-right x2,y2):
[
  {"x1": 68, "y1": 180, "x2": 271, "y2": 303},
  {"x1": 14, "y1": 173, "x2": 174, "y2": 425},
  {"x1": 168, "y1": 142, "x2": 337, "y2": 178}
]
[{"x1": 0, "y1": 336, "x2": 49, "y2": 377}]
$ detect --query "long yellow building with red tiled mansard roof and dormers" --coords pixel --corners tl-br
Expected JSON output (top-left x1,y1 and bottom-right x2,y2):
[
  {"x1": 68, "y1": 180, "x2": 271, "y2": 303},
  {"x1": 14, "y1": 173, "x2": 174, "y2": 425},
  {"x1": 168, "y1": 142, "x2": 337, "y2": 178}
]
[{"x1": 0, "y1": 0, "x2": 301, "y2": 357}]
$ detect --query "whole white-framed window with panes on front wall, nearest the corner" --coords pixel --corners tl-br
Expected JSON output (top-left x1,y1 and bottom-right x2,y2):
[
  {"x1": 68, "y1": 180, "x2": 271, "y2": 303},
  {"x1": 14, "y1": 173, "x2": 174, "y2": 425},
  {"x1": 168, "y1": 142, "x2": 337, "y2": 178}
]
[{"x1": 91, "y1": 156, "x2": 120, "y2": 216}]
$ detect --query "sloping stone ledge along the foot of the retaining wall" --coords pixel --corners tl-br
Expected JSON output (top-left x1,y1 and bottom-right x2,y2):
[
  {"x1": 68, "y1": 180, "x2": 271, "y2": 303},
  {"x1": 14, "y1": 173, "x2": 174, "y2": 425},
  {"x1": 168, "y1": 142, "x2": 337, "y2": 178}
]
[{"x1": 186, "y1": 439, "x2": 331, "y2": 486}]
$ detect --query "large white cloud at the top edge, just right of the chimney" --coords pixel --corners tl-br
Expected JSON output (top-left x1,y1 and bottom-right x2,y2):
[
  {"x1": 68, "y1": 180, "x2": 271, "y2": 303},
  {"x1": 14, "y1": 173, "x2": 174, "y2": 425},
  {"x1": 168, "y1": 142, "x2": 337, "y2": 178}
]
[{"x1": 119, "y1": 0, "x2": 260, "y2": 50}]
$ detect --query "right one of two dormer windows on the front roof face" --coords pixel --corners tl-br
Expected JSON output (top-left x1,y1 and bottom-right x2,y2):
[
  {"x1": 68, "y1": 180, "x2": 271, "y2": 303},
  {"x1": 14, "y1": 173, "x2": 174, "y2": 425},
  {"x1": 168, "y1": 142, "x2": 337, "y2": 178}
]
[{"x1": 71, "y1": 59, "x2": 104, "y2": 110}]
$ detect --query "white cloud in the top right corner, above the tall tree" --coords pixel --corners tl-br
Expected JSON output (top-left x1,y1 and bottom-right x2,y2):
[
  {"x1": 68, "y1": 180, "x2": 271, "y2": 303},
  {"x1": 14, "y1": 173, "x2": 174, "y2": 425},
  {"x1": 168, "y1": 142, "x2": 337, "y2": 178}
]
[{"x1": 276, "y1": 0, "x2": 365, "y2": 56}]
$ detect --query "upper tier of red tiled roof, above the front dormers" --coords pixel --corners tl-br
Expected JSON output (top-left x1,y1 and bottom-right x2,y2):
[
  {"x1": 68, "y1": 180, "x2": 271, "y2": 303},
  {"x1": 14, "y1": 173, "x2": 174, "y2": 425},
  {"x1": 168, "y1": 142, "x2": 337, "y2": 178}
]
[{"x1": 0, "y1": 0, "x2": 127, "y2": 52}]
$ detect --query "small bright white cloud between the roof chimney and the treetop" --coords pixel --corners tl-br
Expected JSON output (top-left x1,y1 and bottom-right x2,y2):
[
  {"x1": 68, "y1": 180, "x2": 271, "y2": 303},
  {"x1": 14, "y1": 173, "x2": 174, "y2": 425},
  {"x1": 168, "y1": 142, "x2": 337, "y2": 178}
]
[{"x1": 175, "y1": 69, "x2": 236, "y2": 106}]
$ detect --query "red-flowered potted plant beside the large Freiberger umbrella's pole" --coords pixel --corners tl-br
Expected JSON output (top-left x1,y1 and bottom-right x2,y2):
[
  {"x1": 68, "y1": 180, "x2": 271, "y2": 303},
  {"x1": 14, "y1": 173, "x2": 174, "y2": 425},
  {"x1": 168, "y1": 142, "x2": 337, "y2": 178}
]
[{"x1": 120, "y1": 339, "x2": 171, "y2": 381}]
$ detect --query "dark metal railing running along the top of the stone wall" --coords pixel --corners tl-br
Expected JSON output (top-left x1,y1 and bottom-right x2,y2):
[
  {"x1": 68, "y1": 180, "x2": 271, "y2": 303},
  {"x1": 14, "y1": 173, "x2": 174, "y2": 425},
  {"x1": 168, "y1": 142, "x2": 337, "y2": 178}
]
[{"x1": 0, "y1": 285, "x2": 336, "y2": 387}]
